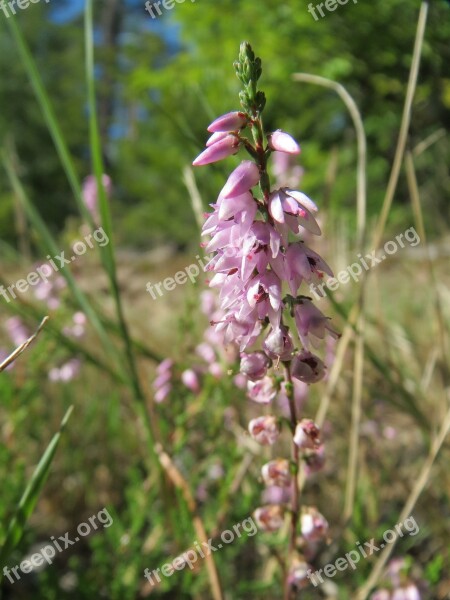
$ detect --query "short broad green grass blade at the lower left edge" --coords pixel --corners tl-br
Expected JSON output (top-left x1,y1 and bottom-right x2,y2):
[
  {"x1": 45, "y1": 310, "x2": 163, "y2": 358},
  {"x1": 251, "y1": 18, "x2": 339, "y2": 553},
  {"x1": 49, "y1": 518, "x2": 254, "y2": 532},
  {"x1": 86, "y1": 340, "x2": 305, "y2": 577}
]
[{"x1": 0, "y1": 406, "x2": 73, "y2": 581}]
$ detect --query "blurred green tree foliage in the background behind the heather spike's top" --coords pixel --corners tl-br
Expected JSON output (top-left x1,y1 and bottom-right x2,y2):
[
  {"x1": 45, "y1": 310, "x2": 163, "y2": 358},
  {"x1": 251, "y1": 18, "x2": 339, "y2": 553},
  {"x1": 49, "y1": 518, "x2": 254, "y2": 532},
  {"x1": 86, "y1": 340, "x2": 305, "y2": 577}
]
[{"x1": 0, "y1": 0, "x2": 450, "y2": 247}]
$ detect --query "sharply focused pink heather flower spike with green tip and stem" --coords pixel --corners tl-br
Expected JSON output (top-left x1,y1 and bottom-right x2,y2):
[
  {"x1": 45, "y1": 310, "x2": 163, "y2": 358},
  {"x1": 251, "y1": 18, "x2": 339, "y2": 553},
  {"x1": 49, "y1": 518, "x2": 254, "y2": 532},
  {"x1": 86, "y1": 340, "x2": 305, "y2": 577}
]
[{"x1": 193, "y1": 42, "x2": 338, "y2": 598}]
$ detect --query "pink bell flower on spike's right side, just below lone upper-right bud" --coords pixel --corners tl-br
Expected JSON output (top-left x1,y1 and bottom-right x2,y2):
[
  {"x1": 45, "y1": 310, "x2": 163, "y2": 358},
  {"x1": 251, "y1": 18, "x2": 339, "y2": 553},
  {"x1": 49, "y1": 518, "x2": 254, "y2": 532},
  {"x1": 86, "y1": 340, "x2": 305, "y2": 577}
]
[{"x1": 269, "y1": 188, "x2": 321, "y2": 236}]
